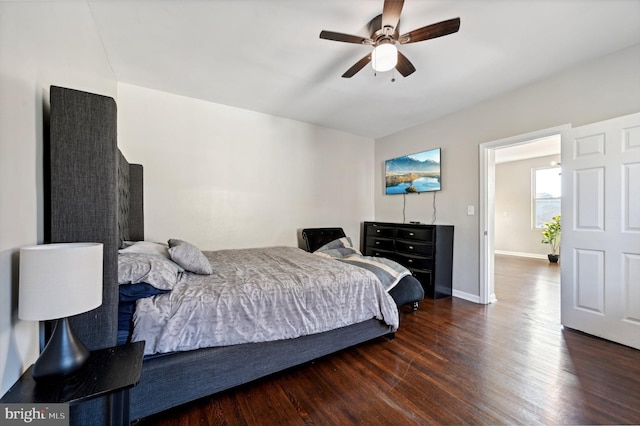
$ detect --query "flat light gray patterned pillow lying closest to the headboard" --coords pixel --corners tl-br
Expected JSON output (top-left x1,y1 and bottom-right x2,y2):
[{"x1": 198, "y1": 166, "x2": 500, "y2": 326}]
[{"x1": 118, "y1": 253, "x2": 184, "y2": 290}]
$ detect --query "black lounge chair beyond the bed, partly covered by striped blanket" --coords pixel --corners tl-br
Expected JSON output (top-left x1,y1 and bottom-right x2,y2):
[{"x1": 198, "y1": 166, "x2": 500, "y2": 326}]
[{"x1": 302, "y1": 228, "x2": 424, "y2": 311}]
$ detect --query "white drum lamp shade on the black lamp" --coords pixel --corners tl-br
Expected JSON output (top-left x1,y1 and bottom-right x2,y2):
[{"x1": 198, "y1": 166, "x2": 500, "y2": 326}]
[{"x1": 18, "y1": 243, "x2": 102, "y2": 321}]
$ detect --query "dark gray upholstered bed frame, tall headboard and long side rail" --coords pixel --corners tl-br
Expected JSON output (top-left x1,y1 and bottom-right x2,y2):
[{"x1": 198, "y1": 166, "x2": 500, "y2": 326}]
[{"x1": 44, "y1": 86, "x2": 391, "y2": 425}]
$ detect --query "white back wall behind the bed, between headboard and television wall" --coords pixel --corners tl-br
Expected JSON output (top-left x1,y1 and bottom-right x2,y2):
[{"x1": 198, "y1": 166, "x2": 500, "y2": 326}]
[{"x1": 118, "y1": 84, "x2": 374, "y2": 250}]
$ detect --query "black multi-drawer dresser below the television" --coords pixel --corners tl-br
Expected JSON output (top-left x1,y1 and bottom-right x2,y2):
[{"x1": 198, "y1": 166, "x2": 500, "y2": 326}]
[{"x1": 362, "y1": 222, "x2": 453, "y2": 299}]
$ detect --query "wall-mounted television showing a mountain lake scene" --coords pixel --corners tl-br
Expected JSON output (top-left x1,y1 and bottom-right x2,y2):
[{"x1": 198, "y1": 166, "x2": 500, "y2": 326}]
[{"x1": 384, "y1": 148, "x2": 442, "y2": 194}]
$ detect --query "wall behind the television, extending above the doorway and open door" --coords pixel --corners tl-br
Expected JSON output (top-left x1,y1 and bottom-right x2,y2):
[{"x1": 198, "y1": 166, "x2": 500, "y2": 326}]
[{"x1": 375, "y1": 45, "x2": 640, "y2": 299}]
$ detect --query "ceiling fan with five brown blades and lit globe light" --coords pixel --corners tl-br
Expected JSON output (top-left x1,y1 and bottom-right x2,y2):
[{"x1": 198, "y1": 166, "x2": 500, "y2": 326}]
[{"x1": 320, "y1": 0, "x2": 460, "y2": 78}]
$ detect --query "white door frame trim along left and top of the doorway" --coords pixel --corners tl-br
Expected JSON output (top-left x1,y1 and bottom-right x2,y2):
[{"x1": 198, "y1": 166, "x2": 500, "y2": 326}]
[{"x1": 478, "y1": 124, "x2": 571, "y2": 305}]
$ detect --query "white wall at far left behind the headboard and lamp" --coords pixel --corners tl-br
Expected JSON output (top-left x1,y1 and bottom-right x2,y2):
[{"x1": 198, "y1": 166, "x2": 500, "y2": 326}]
[{"x1": 0, "y1": 1, "x2": 116, "y2": 395}]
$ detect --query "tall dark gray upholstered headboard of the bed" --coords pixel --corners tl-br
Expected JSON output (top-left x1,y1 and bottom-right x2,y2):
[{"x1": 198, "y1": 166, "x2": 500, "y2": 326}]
[{"x1": 44, "y1": 86, "x2": 144, "y2": 350}]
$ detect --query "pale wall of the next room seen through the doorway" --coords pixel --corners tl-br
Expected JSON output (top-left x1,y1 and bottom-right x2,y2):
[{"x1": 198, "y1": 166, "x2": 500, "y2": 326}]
[{"x1": 494, "y1": 155, "x2": 560, "y2": 259}]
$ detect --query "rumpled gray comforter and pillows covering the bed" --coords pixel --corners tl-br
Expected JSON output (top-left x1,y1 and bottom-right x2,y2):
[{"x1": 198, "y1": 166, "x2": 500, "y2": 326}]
[{"x1": 119, "y1": 243, "x2": 400, "y2": 356}]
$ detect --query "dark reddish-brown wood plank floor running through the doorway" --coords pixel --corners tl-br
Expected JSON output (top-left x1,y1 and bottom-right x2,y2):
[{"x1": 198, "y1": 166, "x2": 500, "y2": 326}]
[{"x1": 138, "y1": 256, "x2": 640, "y2": 426}]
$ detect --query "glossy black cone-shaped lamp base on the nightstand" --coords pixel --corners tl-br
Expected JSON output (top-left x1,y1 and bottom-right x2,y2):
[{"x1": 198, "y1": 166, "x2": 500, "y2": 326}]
[{"x1": 33, "y1": 318, "x2": 89, "y2": 382}]
